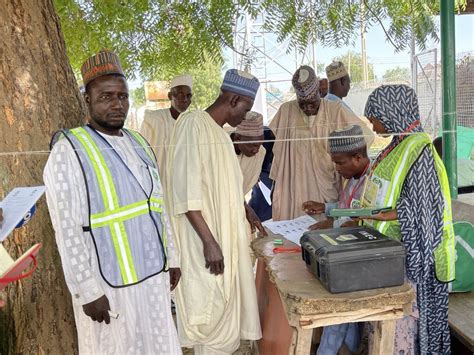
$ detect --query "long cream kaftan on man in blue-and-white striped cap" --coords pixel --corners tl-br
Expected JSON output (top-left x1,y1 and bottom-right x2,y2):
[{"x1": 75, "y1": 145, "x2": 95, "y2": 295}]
[{"x1": 167, "y1": 111, "x2": 261, "y2": 353}]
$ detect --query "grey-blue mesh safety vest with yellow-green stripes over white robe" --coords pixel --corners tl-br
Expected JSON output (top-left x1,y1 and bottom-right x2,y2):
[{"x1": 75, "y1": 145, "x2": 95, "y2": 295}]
[{"x1": 53, "y1": 126, "x2": 167, "y2": 287}]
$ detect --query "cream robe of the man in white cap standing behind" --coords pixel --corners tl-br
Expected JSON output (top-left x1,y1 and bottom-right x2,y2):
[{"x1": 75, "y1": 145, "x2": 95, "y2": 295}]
[{"x1": 140, "y1": 108, "x2": 176, "y2": 175}]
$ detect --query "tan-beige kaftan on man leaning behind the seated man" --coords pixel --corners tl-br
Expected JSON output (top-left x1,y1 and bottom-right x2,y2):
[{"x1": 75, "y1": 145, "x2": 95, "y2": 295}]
[{"x1": 270, "y1": 99, "x2": 374, "y2": 221}]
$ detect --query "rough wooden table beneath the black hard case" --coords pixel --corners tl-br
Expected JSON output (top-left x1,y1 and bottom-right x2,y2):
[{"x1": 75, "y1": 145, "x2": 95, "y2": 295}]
[{"x1": 252, "y1": 235, "x2": 415, "y2": 355}]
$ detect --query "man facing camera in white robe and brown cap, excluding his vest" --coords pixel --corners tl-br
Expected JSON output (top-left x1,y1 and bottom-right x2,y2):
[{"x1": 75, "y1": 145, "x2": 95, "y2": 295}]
[{"x1": 44, "y1": 52, "x2": 181, "y2": 355}]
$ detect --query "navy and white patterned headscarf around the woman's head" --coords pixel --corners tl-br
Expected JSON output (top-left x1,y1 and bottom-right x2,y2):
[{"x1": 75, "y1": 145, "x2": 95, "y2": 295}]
[{"x1": 364, "y1": 85, "x2": 423, "y2": 133}]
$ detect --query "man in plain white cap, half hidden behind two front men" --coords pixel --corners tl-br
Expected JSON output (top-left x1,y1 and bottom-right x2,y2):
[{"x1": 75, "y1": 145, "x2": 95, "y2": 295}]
[{"x1": 140, "y1": 74, "x2": 193, "y2": 174}]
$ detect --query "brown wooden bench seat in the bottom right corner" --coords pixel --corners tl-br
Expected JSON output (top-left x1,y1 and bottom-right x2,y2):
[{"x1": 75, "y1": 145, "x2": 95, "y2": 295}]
[{"x1": 449, "y1": 292, "x2": 474, "y2": 352}]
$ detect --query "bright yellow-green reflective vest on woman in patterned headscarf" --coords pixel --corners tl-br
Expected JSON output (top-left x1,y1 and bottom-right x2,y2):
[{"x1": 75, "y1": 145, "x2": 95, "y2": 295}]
[{"x1": 362, "y1": 133, "x2": 455, "y2": 282}]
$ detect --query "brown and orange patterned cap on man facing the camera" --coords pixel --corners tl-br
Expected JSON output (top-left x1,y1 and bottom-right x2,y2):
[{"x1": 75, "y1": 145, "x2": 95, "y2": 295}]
[{"x1": 81, "y1": 49, "x2": 125, "y2": 86}]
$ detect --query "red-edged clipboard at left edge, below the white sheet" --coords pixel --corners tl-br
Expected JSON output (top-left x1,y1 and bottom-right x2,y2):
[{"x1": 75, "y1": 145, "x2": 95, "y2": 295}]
[{"x1": 0, "y1": 243, "x2": 42, "y2": 291}]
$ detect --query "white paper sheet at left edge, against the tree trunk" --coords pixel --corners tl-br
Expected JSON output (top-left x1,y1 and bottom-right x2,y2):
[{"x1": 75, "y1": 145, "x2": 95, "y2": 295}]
[{"x1": 0, "y1": 186, "x2": 45, "y2": 242}]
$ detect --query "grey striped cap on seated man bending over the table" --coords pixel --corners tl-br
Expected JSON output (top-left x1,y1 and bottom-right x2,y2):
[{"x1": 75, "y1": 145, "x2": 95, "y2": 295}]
[{"x1": 329, "y1": 125, "x2": 367, "y2": 153}]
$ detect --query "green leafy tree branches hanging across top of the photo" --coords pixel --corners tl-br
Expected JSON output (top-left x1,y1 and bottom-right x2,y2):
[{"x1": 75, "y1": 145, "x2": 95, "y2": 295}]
[{"x1": 54, "y1": 0, "x2": 452, "y2": 79}]
